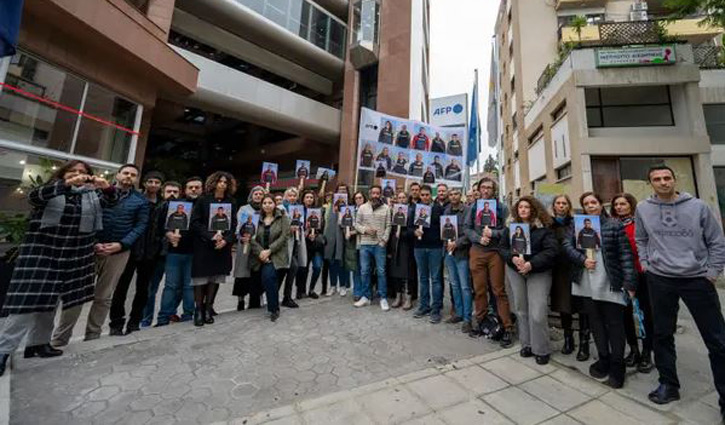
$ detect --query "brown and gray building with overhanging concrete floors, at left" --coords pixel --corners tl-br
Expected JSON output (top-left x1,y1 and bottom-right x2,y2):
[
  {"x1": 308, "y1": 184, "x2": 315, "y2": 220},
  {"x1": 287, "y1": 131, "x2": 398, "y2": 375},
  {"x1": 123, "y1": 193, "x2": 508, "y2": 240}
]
[{"x1": 0, "y1": 0, "x2": 429, "y2": 209}]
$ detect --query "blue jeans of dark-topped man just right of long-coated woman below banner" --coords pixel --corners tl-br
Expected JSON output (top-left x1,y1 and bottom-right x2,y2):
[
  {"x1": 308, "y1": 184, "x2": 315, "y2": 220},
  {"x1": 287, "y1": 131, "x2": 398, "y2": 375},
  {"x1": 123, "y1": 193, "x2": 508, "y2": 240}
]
[{"x1": 413, "y1": 248, "x2": 443, "y2": 314}]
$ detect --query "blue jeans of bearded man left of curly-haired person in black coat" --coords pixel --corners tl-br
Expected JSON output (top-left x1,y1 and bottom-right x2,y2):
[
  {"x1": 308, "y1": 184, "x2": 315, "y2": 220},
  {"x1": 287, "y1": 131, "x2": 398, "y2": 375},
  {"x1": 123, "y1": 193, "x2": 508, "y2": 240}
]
[{"x1": 156, "y1": 254, "x2": 194, "y2": 324}]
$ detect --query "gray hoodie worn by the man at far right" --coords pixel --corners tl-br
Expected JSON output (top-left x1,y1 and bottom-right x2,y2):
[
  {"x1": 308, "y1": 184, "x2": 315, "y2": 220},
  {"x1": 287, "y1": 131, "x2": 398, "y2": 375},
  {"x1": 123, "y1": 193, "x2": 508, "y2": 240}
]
[{"x1": 635, "y1": 193, "x2": 725, "y2": 278}]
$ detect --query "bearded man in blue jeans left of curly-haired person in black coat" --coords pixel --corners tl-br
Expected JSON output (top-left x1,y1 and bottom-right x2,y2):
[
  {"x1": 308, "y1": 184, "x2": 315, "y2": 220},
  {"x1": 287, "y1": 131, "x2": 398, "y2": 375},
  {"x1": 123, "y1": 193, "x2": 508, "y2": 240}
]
[{"x1": 156, "y1": 177, "x2": 203, "y2": 326}]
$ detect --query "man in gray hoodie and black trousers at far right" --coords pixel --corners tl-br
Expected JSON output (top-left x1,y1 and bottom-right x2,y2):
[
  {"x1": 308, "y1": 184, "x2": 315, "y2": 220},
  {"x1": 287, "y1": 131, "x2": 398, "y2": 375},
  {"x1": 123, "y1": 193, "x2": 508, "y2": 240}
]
[{"x1": 635, "y1": 165, "x2": 725, "y2": 419}]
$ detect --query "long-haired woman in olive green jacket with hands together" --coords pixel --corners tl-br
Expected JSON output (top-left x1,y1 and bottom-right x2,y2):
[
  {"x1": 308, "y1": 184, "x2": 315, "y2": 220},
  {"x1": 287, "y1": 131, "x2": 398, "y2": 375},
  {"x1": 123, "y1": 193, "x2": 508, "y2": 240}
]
[{"x1": 250, "y1": 194, "x2": 290, "y2": 322}]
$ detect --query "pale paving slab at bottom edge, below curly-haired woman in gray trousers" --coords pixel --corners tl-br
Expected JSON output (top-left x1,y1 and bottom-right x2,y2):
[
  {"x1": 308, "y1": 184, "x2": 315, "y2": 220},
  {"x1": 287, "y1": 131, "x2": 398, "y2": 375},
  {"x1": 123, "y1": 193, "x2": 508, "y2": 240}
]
[{"x1": 483, "y1": 387, "x2": 559, "y2": 425}]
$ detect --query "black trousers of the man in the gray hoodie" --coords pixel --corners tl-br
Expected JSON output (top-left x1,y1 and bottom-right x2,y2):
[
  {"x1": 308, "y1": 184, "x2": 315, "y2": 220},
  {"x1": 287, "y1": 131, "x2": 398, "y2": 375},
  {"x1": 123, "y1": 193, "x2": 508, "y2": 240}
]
[{"x1": 647, "y1": 273, "x2": 725, "y2": 413}]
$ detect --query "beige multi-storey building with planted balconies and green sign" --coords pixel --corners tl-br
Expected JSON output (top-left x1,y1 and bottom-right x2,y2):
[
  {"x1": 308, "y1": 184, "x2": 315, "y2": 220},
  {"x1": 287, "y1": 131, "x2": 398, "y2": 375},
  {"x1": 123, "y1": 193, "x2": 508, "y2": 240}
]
[{"x1": 491, "y1": 0, "x2": 725, "y2": 217}]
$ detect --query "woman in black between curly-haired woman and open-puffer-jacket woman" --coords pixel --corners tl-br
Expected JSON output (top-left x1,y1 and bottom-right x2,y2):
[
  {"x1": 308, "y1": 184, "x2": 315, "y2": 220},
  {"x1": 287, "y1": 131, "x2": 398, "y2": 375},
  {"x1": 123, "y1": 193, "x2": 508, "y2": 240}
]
[{"x1": 551, "y1": 195, "x2": 590, "y2": 362}]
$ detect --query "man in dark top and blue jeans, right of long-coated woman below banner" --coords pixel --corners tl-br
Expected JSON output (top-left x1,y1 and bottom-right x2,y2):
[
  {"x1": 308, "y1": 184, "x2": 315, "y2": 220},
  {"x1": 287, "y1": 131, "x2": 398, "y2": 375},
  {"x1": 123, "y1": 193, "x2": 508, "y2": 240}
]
[{"x1": 407, "y1": 185, "x2": 443, "y2": 323}]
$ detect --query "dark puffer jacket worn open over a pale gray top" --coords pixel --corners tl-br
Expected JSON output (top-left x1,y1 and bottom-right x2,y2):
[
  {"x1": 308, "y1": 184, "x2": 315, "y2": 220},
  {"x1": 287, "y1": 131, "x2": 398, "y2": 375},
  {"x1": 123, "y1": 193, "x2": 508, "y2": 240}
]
[{"x1": 564, "y1": 215, "x2": 637, "y2": 292}]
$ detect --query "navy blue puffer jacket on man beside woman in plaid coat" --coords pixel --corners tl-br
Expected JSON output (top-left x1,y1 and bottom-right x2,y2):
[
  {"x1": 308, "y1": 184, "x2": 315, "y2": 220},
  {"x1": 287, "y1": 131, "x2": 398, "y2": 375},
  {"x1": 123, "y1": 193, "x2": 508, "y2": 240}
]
[{"x1": 98, "y1": 188, "x2": 150, "y2": 251}]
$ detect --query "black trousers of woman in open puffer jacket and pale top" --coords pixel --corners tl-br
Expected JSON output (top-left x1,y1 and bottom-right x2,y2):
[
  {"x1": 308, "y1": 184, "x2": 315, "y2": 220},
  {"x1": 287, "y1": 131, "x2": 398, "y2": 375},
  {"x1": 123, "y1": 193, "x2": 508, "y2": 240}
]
[{"x1": 582, "y1": 298, "x2": 625, "y2": 379}]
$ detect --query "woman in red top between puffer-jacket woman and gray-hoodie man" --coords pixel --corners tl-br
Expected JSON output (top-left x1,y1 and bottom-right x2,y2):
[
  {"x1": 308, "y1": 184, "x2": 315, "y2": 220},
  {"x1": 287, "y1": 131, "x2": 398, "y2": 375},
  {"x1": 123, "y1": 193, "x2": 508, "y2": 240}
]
[{"x1": 609, "y1": 193, "x2": 654, "y2": 373}]
